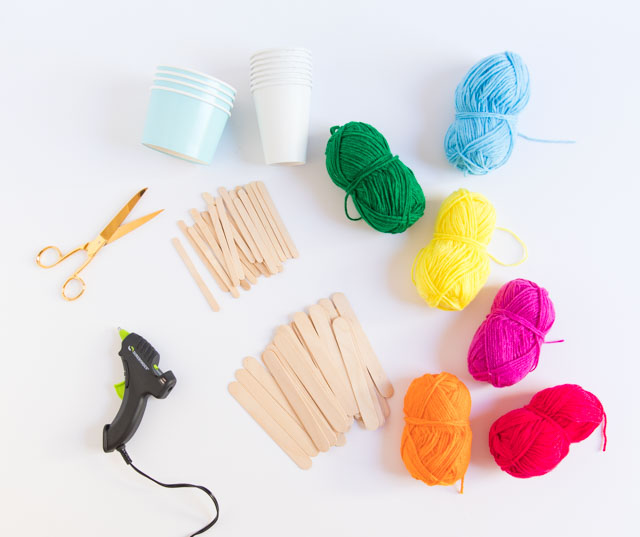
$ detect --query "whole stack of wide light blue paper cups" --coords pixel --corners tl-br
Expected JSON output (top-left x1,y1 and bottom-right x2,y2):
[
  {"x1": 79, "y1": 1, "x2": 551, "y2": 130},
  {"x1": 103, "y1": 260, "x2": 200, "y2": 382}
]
[{"x1": 142, "y1": 65, "x2": 236, "y2": 164}]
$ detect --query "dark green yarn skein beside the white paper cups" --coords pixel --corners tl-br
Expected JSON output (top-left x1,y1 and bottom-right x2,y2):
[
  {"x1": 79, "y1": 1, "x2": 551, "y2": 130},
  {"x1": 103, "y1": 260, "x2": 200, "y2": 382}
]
[{"x1": 325, "y1": 121, "x2": 425, "y2": 233}]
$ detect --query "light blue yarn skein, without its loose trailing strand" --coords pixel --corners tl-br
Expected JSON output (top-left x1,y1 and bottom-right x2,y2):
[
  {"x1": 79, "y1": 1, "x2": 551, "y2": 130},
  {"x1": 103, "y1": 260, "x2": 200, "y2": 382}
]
[{"x1": 444, "y1": 52, "x2": 530, "y2": 175}]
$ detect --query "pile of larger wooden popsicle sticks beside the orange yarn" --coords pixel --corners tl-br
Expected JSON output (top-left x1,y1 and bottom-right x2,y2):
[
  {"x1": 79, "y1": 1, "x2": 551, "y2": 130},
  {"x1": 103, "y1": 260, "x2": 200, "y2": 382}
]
[{"x1": 229, "y1": 293, "x2": 393, "y2": 469}]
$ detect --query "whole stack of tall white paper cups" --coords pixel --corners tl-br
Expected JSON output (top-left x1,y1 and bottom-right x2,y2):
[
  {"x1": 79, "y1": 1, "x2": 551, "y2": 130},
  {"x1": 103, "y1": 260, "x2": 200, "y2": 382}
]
[{"x1": 249, "y1": 48, "x2": 311, "y2": 166}]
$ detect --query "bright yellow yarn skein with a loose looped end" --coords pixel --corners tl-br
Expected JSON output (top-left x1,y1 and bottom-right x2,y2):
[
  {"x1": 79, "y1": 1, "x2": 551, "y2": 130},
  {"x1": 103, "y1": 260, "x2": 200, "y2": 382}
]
[{"x1": 412, "y1": 188, "x2": 527, "y2": 311}]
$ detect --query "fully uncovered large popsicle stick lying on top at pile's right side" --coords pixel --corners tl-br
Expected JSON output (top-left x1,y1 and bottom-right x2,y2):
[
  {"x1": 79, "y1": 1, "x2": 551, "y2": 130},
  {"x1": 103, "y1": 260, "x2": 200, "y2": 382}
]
[{"x1": 332, "y1": 317, "x2": 378, "y2": 430}]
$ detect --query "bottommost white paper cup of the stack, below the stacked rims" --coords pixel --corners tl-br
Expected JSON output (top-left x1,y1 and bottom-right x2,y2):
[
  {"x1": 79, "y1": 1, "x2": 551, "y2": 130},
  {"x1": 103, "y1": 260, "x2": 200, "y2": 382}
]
[{"x1": 253, "y1": 84, "x2": 311, "y2": 166}]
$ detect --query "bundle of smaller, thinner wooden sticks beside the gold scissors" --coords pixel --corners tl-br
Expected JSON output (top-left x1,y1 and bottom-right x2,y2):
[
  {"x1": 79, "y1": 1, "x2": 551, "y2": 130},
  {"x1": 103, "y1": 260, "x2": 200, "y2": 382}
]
[{"x1": 172, "y1": 181, "x2": 298, "y2": 311}]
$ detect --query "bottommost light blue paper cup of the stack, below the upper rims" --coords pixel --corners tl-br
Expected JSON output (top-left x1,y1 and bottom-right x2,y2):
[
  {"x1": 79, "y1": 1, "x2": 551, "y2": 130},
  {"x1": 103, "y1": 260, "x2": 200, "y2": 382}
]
[{"x1": 142, "y1": 86, "x2": 231, "y2": 164}]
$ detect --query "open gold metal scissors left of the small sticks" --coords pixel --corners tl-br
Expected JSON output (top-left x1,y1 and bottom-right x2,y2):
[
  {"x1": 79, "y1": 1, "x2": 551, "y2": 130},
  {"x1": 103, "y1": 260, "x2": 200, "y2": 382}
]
[{"x1": 36, "y1": 188, "x2": 164, "y2": 301}]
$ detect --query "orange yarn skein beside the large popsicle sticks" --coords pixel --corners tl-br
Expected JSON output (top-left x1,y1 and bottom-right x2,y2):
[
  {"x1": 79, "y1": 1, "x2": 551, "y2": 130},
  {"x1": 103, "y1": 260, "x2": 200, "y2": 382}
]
[{"x1": 400, "y1": 373, "x2": 471, "y2": 492}]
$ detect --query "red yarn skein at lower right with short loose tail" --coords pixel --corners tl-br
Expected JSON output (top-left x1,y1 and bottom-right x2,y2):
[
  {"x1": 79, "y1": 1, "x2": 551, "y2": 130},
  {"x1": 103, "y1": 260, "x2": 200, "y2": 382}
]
[{"x1": 489, "y1": 384, "x2": 607, "y2": 477}]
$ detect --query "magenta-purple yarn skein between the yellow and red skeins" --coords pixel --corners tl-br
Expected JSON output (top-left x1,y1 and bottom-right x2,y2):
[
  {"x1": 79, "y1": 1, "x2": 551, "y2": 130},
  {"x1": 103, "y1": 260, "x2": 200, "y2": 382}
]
[{"x1": 467, "y1": 279, "x2": 556, "y2": 388}]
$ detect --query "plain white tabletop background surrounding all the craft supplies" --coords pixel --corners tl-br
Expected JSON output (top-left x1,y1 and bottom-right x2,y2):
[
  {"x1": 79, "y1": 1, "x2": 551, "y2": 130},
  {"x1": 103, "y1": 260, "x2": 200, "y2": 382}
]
[{"x1": 0, "y1": 0, "x2": 640, "y2": 537}]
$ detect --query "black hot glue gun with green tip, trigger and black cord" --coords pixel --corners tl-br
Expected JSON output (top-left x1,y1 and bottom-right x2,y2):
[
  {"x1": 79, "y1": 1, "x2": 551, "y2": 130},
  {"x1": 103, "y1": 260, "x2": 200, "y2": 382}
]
[{"x1": 102, "y1": 329, "x2": 220, "y2": 537}]
